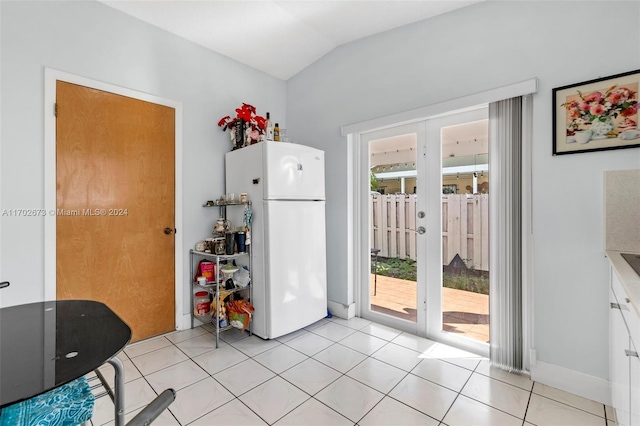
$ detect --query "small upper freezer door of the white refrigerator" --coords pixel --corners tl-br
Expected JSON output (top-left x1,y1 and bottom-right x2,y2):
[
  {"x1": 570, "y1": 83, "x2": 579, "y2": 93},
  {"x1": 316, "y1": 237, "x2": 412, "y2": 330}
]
[{"x1": 263, "y1": 142, "x2": 325, "y2": 200}]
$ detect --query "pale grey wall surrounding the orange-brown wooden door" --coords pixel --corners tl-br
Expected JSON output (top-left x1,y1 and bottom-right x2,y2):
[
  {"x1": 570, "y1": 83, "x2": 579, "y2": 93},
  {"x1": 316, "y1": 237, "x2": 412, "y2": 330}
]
[{"x1": 0, "y1": 1, "x2": 285, "y2": 314}]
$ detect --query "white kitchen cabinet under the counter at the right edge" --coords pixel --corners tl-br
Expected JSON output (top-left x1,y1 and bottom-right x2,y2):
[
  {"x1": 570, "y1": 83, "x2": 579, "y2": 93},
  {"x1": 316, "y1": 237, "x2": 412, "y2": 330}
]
[{"x1": 609, "y1": 269, "x2": 640, "y2": 426}]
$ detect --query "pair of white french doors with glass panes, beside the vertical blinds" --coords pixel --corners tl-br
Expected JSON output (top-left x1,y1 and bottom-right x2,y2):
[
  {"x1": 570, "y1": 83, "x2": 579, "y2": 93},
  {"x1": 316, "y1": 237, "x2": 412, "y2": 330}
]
[{"x1": 359, "y1": 108, "x2": 488, "y2": 354}]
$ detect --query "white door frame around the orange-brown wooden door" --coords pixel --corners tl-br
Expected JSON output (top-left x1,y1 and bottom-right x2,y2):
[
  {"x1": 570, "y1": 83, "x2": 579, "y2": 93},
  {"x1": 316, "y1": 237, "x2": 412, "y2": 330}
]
[{"x1": 44, "y1": 68, "x2": 183, "y2": 329}]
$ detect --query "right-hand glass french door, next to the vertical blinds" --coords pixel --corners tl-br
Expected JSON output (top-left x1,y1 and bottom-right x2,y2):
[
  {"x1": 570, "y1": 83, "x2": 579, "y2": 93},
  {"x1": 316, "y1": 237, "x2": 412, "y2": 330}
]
[{"x1": 426, "y1": 108, "x2": 489, "y2": 353}]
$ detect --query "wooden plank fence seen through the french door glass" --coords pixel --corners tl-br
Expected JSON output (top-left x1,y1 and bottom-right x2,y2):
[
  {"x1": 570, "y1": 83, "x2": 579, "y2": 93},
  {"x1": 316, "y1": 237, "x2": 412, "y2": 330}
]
[{"x1": 370, "y1": 194, "x2": 489, "y2": 271}]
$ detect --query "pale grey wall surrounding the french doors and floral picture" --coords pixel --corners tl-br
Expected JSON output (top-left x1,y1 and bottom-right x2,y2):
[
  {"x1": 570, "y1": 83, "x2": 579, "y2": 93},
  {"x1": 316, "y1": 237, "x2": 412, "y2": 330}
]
[{"x1": 287, "y1": 1, "x2": 640, "y2": 392}]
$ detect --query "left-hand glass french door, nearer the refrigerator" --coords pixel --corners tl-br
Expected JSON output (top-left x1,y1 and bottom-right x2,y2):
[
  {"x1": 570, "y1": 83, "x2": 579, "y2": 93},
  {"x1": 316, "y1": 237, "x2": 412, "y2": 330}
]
[{"x1": 361, "y1": 123, "x2": 425, "y2": 335}]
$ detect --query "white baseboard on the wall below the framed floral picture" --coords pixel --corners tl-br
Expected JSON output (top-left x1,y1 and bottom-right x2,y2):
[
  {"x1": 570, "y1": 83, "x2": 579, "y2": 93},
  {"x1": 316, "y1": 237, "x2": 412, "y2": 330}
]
[{"x1": 530, "y1": 360, "x2": 611, "y2": 406}]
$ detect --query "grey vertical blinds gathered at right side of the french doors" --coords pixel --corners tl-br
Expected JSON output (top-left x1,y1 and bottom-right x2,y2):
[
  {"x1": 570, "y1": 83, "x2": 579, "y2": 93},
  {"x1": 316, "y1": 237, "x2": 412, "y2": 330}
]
[{"x1": 489, "y1": 97, "x2": 523, "y2": 371}]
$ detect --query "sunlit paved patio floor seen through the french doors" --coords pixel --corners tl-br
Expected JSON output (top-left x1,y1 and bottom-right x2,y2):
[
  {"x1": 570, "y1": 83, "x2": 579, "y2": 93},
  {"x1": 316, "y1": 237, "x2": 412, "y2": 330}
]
[{"x1": 371, "y1": 275, "x2": 489, "y2": 342}]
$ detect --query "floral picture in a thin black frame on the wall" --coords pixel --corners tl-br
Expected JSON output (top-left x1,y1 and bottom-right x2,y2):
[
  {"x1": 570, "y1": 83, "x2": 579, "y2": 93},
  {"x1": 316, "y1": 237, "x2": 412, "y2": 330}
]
[{"x1": 553, "y1": 70, "x2": 640, "y2": 155}]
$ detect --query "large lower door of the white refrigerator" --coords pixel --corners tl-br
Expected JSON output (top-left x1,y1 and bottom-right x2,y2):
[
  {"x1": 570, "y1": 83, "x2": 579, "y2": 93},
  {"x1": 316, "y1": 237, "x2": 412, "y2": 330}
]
[{"x1": 264, "y1": 201, "x2": 327, "y2": 339}]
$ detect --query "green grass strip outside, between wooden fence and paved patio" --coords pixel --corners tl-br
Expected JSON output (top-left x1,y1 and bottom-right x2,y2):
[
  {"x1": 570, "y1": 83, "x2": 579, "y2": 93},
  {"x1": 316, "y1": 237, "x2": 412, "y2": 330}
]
[{"x1": 372, "y1": 257, "x2": 489, "y2": 294}]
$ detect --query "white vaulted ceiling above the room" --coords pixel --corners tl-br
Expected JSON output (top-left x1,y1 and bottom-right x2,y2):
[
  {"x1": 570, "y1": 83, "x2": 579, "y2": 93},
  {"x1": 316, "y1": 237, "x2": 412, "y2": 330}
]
[{"x1": 98, "y1": 0, "x2": 482, "y2": 80}]
